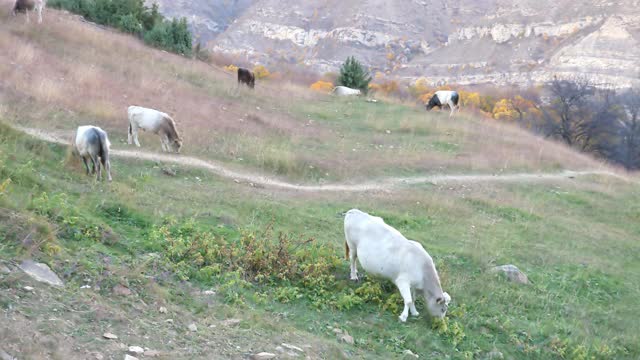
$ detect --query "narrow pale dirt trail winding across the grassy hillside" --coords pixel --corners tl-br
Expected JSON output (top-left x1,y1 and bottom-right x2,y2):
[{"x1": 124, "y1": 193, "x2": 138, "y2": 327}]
[{"x1": 16, "y1": 127, "x2": 633, "y2": 192}]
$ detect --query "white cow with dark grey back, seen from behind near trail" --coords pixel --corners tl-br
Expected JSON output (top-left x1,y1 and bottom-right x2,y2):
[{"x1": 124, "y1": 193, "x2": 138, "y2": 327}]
[{"x1": 74, "y1": 125, "x2": 111, "y2": 181}]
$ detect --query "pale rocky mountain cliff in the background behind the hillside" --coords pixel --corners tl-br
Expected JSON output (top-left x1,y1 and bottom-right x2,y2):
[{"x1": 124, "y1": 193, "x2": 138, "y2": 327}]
[{"x1": 151, "y1": 0, "x2": 640, "y2": 87}]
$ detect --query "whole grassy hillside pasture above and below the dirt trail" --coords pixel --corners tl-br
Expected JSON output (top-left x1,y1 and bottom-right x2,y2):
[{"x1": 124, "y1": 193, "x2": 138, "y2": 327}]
[{"x1": 0, "y1": 3, "x2": 640, "y2": 359}]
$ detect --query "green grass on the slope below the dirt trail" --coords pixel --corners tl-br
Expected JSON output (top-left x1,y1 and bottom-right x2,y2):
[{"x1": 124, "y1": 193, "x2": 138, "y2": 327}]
[{"x1": 0, "y1": 125, "x2": 640, "y2": 359}]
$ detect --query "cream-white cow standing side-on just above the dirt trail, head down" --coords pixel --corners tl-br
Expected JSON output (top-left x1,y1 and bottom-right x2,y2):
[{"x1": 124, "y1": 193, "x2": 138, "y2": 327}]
[{"x1": 127, "y1": 106, "x2": 182, "y2": 153}]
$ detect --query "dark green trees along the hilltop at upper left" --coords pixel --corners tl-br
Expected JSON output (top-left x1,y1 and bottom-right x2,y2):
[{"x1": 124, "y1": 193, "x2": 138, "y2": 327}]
[{"x1": 48, "y1": 0, "x2": 193, "y2": 56}]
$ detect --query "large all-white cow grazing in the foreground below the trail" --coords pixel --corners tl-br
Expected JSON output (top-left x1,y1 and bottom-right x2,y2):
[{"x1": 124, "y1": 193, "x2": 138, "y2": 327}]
[{"x1": 344, "y1": 209, "x2": 451, "y2": 322}]
